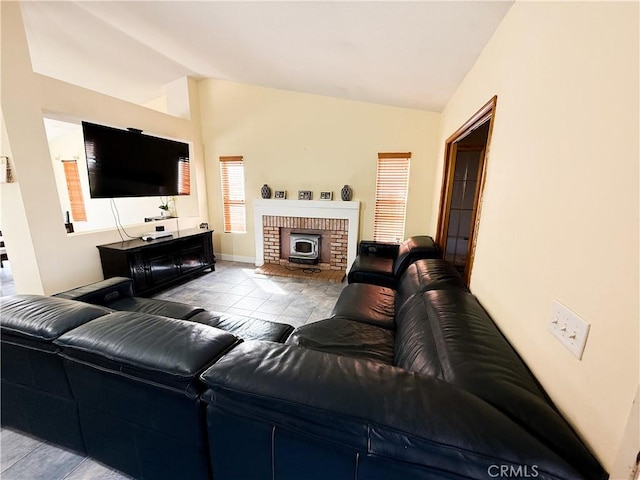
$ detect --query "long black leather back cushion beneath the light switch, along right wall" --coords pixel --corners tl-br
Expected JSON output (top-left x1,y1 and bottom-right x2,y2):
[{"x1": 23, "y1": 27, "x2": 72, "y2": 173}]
[{"x1": 422, "y1": 290, "x2": 599, "y2": 472}]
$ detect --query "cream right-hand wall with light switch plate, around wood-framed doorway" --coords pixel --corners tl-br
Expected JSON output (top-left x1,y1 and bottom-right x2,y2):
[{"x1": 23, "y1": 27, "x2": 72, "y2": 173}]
[{"x1": 432, "y1": 2, "x2": 640, "y2": 472}]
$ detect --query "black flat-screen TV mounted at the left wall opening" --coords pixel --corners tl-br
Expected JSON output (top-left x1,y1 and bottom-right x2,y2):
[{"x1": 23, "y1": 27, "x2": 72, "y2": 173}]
[{"x1": 82, "y1": 122, "x2": 190, "y2": 198}]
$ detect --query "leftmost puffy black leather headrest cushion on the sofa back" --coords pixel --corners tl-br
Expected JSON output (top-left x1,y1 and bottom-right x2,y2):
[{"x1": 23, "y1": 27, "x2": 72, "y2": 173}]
[{"x1": 0, "y1": 295, "x2": 110, "y2": 342}]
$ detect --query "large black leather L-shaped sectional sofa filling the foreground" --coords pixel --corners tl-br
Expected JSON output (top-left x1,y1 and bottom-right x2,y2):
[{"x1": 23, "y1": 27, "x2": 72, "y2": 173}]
[{"x1": 2, "y1": 238, "x2": 607, "y2": 480}]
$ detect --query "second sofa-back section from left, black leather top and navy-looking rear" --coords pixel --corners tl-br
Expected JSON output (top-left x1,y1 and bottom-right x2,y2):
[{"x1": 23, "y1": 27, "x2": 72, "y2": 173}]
[{"x1": 56, "y1": 312, "x2": 238, "y2": 480}]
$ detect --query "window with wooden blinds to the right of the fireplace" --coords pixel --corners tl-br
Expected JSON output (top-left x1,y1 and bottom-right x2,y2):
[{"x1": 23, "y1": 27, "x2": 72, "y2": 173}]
[{"x1": 373, "y1": 152, "x2": 411, "y2": 242}]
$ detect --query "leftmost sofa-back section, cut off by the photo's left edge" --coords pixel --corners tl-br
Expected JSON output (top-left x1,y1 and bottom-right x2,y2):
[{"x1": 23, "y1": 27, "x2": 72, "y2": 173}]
[{"x1": 0, "y1": 295, "x2": 109, "y2": 453}]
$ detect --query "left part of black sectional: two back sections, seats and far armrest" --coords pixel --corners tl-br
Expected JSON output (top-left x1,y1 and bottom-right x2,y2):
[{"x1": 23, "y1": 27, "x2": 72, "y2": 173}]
[{"x1": 0, "y1": 278, "x2": 293, "y2": 480}]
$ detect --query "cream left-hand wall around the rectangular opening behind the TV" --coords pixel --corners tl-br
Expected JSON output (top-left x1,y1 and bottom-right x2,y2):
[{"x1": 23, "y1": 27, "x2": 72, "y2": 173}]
[{"x1": 0, "y1": 2, "x2": 207, "y2": 294}]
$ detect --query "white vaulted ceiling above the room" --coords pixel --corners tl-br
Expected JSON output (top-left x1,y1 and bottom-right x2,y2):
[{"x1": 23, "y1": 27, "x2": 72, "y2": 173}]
[{"x1": 21, "y1": 0, "x2": 513, "y2": 111}]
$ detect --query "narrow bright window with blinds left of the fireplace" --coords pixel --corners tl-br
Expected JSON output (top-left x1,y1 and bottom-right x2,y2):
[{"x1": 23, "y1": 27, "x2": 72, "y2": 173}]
[{"x1": 220, "y1": 157, "x2": 247, "y2": 233}]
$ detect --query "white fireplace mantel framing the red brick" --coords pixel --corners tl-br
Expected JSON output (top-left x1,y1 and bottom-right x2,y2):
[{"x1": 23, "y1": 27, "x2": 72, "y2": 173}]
[{"x1": 253, "y1": 199, "x2": 360, "y2": 270}]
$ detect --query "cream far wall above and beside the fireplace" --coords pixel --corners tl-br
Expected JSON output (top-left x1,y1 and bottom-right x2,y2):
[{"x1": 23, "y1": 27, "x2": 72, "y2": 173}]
[{"x1": 200, "y1": 80, "x2": 440, "y2": 261}]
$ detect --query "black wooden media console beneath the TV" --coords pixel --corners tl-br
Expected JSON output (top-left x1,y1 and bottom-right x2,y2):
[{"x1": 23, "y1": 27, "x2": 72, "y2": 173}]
[{"x1": 98, "y1": 228, "x2": 216, "y2": 295}]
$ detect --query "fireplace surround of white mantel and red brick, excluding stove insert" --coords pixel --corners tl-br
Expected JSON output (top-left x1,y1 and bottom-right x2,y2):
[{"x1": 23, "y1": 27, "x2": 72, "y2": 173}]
[{"x1": 253, "y1": 199, "x2": 360, "y2": 271}]
